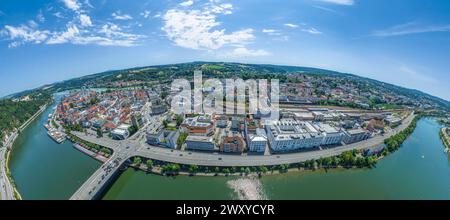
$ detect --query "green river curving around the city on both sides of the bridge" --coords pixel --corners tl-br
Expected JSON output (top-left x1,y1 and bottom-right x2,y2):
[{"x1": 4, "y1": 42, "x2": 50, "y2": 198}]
[{"x1": 10, "y1": 102, "x2": 450, "y2": 200}]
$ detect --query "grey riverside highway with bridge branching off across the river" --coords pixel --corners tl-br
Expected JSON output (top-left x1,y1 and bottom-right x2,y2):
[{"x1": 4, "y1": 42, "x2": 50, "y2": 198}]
[{"x1": 71, "y1": 114, "x2": 414, "y2": 200}]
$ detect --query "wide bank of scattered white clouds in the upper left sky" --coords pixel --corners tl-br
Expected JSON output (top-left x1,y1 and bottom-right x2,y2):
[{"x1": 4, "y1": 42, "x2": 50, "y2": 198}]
[{"x1": 0, "y1": 0, "x2": 146, "y2": 47}]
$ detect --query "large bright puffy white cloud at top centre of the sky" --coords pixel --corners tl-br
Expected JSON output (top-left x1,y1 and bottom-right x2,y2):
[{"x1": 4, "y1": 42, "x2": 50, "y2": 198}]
[{"x1": 162, "y1": 4, "x2": 255, "y2": 50}]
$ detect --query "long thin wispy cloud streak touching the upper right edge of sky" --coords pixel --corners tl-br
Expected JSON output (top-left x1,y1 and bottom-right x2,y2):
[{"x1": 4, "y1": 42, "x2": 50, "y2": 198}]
[{"x1": 372, "y1": 22, "x2": 450, "y2": 37}]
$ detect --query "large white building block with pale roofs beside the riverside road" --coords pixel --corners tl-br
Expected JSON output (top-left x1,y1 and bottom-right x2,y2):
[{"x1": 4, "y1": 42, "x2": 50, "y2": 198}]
[{"x1": 266, "y1": 119, "x2": 324, "y2": 152}]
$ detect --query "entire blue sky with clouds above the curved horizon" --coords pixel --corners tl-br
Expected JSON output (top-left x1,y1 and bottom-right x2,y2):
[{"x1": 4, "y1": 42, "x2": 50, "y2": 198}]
[{"x1": 0, "y1": 0, "x2": 450, "y2": 100}]
